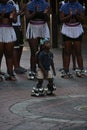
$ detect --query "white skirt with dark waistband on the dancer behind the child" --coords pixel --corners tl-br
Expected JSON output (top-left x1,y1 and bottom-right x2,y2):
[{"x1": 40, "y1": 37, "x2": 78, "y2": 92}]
[{"x1": 26, "y1": 21, "x2": 50, "y2": 39}]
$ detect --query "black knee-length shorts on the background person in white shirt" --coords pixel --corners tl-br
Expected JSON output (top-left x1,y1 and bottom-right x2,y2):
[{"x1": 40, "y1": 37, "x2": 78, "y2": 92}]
[{"x1": 13, "y1": 26, "x2": 24, "y2": 48}]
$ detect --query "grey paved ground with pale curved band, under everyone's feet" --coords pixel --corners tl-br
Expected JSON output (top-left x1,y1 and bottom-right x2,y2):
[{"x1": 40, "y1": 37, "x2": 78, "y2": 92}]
[{"x1": 0, "y1": 39, "x2": 87, "y2": 130}]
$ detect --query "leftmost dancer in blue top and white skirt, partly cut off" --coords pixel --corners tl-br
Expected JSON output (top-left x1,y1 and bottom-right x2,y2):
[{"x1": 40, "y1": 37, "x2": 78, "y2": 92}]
[{"x1": 0, "y1": 0, "x2": 16, "y2": 81}]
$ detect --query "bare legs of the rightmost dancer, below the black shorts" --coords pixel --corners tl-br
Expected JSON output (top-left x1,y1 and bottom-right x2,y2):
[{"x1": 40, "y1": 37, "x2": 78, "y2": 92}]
[{"x1": 62, "y1": 41, "x2": 84, "y2": 78}]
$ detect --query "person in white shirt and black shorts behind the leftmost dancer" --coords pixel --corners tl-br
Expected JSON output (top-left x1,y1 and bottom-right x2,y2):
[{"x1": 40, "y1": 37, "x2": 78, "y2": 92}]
[{"x1": 8, "y1": 0, "x2": 27, "y2": 74}]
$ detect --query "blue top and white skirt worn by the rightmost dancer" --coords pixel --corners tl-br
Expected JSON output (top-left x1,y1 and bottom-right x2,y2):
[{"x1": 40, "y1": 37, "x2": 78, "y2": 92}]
[{"x1": 60, "y1": 2, "x2": 84, "y2": 38}]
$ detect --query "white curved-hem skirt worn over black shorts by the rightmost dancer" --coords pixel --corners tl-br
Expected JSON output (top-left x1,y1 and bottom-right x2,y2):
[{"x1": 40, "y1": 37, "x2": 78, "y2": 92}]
[{"x1": 61, "y1": 24, "x2": 84, "y2": 38}]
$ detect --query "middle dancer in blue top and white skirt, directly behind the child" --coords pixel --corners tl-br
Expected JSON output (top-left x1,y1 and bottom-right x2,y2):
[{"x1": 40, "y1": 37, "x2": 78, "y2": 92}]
[{"x1": 26, "y1": 0, "x2": 50, "y2": 77}]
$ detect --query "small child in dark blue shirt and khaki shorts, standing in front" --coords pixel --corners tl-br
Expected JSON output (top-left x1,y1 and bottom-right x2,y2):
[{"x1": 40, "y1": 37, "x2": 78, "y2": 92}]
[{"x1": 32, "y1": 38, "x2": 56, "y2": 96}]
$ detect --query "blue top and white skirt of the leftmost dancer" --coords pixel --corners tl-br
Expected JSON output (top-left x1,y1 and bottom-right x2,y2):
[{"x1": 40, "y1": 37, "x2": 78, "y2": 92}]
[{"x1": 0, "y1": 4, "x2": 16, "y2": 43}]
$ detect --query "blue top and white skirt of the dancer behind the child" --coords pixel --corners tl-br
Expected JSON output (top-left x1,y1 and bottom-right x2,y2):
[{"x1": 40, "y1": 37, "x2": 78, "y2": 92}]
[{"x1": 26, "y1": 0, "x2": 50, "y2": 39}]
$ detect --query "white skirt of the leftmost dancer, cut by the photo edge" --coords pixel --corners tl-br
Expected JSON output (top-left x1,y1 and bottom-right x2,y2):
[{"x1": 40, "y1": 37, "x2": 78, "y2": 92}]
[{"x1": 0, "y1": 26, "x2": 16, "y2": 43}]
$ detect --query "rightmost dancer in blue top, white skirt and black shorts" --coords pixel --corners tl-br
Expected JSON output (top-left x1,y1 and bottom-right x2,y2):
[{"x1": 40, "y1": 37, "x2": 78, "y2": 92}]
[{"x1": 60, "y1": 0, "x2": 84, "y2": 78}]
